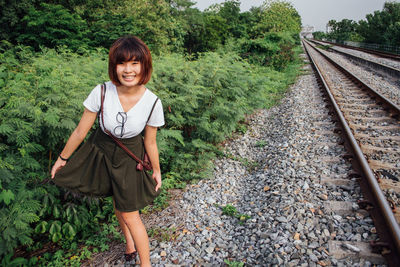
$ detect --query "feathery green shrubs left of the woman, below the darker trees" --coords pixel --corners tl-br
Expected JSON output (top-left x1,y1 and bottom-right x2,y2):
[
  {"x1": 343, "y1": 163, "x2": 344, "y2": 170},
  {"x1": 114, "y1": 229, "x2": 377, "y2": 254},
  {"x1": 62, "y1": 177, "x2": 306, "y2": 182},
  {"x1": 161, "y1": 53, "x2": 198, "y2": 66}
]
[{"x1": 0, "y1": 47, "x2": 112, "y2": 260}]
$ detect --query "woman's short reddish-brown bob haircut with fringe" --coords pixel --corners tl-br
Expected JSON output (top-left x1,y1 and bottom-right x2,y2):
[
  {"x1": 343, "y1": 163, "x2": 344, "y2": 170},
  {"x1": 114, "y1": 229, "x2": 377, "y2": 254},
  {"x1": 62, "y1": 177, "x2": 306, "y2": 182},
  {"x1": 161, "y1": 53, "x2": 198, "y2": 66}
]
[{"x1": 108, "y1": 35, "x2": 153, "y2": 86}]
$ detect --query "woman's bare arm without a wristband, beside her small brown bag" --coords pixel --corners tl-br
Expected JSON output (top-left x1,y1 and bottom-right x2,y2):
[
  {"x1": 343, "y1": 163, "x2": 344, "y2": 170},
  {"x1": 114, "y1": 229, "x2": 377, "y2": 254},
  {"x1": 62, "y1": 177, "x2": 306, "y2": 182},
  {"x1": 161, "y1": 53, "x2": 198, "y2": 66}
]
[{"x1": 144, "y1": 125, "x2": 161, "y2": 191}]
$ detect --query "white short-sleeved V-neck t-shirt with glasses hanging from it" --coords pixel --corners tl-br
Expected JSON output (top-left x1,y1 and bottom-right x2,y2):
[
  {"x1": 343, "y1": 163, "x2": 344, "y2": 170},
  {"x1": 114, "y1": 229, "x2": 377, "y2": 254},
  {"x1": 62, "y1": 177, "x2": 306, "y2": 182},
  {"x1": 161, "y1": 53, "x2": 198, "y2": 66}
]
[{"x1": 83, "y1": 82, "x2": 164, "y2": 138}]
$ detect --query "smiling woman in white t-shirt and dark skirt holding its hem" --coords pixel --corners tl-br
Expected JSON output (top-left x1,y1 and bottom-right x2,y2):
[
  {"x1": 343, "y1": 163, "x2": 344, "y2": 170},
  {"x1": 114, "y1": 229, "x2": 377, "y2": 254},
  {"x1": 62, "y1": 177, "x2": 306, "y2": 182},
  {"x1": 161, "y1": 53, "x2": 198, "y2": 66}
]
[{"x1": 51, "y1": 36, "x2": 164, "y2": 266}]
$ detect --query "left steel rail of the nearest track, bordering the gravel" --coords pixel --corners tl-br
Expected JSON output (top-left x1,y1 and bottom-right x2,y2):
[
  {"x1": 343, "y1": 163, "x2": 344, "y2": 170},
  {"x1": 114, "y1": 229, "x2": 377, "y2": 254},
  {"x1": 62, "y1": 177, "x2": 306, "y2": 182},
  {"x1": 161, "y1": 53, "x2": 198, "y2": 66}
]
[{"x1": 303, "y1": 40, "x2": 400, "y2": 266}]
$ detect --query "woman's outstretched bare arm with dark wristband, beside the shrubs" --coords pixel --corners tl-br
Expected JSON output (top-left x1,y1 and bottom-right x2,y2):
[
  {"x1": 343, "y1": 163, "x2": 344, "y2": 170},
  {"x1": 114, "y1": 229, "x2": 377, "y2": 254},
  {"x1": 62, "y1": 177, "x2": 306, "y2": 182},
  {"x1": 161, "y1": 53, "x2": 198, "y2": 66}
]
[{"x1": 51, "y1": 108, "x2": 97, "y2": 178}]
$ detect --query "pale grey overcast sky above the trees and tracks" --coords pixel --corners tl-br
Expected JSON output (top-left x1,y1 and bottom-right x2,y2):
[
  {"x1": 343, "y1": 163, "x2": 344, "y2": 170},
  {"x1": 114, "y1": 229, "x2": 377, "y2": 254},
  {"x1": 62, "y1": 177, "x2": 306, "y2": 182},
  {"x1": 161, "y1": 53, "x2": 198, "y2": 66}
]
[{"x1": 193, "y1": 0, "x2": 394, "y2": 31}]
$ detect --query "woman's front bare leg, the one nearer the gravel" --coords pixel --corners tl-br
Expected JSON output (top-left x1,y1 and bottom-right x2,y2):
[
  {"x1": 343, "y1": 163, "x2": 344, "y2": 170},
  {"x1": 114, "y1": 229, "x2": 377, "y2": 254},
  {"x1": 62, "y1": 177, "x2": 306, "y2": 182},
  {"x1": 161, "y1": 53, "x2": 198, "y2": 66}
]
[{"x1": 121, "y1": 211, "x2": 151, "y2": 267}]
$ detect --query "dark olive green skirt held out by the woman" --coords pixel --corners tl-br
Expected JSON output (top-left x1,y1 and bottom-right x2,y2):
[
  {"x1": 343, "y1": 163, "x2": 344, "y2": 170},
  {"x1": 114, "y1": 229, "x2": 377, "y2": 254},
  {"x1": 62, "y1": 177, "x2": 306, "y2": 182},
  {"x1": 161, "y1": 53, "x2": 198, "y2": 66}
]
[{"x1": 53, "y1": 128, "x2": 160, "y2": 212}]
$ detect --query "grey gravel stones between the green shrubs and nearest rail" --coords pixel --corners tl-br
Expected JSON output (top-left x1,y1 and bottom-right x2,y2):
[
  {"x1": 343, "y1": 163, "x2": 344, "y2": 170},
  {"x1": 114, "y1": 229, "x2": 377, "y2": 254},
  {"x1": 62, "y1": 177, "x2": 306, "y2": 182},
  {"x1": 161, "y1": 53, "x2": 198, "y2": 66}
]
[{"x1": 83, "y1": 53, "x2": 384, "y2": 266}]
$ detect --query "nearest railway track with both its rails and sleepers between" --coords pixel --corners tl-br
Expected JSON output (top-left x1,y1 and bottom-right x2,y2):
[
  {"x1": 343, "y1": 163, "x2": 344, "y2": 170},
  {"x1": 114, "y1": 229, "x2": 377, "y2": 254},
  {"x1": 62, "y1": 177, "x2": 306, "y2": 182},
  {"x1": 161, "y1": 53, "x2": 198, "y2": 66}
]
[{"x1": 304, "y1": 39, "x2": 400, "y2": 266}]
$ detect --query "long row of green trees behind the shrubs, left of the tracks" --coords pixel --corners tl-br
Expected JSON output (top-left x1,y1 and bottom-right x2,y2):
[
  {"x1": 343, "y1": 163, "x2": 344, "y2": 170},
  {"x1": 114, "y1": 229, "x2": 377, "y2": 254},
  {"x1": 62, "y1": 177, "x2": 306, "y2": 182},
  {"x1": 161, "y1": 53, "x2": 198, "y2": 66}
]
[{"x1": 0, "y1": 0, "x2": 301, "y2": 53}]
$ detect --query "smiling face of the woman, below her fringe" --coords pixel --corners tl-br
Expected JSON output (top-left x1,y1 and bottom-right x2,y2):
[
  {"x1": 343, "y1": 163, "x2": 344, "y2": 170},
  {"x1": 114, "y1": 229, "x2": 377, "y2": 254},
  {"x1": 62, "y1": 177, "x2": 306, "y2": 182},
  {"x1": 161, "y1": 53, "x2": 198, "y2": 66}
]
[{"x1": 117, "y1": 60, "x2": 142, "y2": 87}]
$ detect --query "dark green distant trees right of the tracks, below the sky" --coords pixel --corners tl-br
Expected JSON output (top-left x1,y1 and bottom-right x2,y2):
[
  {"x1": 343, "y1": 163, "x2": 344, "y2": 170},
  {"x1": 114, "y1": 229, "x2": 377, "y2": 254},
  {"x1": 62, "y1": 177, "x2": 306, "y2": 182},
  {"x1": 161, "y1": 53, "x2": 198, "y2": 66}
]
[{"x1": 314, "y1": 2, "x2": 400, "y2": 46}]
